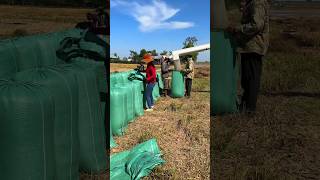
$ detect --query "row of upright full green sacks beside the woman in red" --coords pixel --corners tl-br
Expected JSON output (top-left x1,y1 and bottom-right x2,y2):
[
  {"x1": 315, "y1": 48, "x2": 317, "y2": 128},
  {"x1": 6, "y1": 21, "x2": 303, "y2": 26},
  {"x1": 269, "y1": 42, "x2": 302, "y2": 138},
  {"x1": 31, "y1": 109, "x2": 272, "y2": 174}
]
[{"x1": 110, "y1": 71, "x2": 163, "y2": 140}]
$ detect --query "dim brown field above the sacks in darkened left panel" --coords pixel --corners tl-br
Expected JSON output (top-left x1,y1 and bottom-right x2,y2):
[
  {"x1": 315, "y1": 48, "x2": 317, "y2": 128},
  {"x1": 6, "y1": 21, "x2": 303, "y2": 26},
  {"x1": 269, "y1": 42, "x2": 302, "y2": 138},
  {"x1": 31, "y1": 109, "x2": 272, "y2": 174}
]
[{"x1": 0, "y1": 5, "x2": 92, "y2": 39}]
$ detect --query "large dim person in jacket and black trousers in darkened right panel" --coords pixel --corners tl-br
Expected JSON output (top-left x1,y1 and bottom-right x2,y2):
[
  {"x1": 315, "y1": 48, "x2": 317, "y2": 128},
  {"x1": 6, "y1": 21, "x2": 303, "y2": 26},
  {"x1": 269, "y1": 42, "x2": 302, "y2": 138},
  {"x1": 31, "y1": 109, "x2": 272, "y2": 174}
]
[{"x1": 227, "y1": 0, "x2": 269, "y2": 114}]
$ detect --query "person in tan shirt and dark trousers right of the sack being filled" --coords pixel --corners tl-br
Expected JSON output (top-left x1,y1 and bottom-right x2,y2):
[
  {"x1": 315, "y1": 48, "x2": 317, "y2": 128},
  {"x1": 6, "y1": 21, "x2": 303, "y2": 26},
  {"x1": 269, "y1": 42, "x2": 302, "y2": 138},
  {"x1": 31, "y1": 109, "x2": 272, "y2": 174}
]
[{"x1": 183, "y1": 57, "x2": 194, "y2": 98}]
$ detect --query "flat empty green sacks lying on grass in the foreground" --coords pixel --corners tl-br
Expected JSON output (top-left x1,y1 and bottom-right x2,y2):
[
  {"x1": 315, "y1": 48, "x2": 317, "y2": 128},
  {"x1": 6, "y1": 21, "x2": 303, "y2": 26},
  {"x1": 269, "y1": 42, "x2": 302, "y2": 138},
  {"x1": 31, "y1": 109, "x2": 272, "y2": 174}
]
[{"x1": 110, "y1": 139, "x2": 164, "y2": 180}]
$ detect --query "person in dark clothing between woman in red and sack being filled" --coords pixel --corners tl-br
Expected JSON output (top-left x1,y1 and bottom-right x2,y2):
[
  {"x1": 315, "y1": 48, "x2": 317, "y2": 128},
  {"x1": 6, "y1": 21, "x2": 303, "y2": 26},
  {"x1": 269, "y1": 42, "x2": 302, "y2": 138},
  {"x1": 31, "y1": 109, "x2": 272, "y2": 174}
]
[{"x1": 161, "y1": 57, "x2": 172, "y2": 97}]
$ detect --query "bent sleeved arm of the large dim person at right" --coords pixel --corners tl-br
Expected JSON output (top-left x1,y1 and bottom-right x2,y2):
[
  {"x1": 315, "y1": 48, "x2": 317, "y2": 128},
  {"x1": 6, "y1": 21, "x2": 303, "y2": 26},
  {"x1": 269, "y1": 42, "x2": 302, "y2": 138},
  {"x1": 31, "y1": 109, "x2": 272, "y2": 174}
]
[{"x1": 235, "y1": 2, "x2": 266, "y2": 36}]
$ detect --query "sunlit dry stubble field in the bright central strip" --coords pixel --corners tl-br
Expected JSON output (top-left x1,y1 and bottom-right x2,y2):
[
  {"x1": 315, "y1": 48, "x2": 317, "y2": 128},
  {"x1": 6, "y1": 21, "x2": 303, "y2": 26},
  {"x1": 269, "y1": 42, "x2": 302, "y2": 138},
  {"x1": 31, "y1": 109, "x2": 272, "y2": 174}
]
[{"x1": 111, "y1": 64, "x2": 210, "y2": 179}]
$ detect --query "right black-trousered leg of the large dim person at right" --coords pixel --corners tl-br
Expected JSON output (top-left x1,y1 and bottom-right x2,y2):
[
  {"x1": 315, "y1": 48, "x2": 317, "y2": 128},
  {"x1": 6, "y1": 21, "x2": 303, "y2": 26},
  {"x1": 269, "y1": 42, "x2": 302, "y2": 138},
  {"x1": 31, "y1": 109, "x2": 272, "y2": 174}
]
[{"x1": 247, "y1": 53, "x2": 262, "y2": 112}]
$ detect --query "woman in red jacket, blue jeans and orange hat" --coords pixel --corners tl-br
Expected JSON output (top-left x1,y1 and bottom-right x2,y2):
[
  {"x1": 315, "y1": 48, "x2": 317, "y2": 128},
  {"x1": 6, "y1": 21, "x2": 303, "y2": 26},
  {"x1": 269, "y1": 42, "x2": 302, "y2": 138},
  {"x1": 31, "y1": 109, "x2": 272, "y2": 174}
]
[{"x1": 143, "y1": 54, "x2": 157, "y2": 111}]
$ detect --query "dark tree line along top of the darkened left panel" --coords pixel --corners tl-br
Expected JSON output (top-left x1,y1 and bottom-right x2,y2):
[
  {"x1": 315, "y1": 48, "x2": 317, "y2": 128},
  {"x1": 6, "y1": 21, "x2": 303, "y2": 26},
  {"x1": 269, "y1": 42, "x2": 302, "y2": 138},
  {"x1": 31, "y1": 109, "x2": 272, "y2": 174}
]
[{"x1": 0, "y1": 0, "x2": 109, "y2": 8}]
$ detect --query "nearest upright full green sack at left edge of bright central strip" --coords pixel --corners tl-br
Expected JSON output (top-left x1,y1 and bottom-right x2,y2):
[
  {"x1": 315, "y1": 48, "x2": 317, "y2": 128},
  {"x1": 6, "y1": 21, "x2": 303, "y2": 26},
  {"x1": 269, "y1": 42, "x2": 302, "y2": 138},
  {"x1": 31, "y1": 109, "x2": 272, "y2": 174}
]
[{"x1": 110, "y1": 87, "x2": 128, "y2": 135}]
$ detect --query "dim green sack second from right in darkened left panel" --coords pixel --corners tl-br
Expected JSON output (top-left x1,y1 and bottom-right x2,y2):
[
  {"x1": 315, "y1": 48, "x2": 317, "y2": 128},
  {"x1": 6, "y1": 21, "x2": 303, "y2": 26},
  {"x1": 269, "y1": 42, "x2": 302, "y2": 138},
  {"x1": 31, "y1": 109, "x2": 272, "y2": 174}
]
[{"x1": 14, "y1": 65, "x2": 79, "y2": 180}]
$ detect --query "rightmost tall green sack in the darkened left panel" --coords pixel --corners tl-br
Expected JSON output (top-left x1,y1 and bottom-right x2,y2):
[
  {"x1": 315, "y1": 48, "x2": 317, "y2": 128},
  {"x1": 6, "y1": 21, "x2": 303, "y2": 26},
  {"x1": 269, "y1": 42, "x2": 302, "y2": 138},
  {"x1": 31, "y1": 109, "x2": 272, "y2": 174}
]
[{"x1": 72, "y1": 64, "x2": 106, "y2": 173}]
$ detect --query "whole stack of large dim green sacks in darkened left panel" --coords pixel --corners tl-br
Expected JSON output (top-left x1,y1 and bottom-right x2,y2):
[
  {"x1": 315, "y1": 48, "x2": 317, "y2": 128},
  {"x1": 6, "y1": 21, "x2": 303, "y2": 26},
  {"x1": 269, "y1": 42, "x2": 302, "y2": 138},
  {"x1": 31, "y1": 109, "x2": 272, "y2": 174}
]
[{"x1": 0, "y1": 29, "x2": 107, "y2": 180}]
